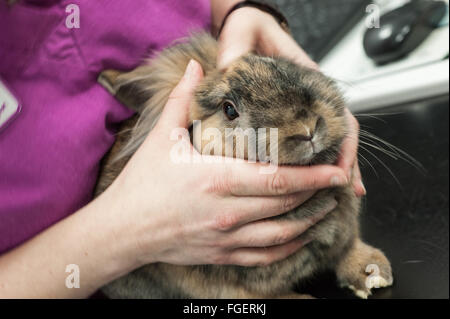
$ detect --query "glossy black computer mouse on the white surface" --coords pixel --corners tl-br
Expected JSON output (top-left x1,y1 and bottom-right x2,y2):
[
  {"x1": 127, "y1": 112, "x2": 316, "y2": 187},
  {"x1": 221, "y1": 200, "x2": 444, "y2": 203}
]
[{"x1": 364, "y1": 0, "x2": 448, "y2": 64}]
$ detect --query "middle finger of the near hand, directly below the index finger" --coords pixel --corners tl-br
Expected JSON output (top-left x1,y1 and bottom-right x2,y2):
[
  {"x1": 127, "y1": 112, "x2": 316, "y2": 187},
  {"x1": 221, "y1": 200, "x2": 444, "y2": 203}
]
[{"x1": 217, "y1": 191, "x2": 316, "y2": 231}]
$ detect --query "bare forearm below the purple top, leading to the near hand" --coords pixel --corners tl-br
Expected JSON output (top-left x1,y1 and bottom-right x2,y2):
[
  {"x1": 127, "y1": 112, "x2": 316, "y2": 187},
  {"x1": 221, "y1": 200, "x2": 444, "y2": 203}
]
[{"x1": 0, "y1": 192, "x2": 138, "y2": 298}]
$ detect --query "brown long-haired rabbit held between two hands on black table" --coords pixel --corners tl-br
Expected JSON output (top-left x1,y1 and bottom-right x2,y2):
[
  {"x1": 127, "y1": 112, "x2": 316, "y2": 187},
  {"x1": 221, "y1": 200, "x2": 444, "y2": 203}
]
[{"x1": 96, "y1": 34, "x2": 393, "y2": 299}]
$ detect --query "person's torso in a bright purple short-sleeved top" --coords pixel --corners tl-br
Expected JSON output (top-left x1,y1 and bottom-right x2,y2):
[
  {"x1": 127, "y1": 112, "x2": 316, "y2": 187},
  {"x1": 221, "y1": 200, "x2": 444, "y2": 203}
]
[{"x1": 0, "y1": 0, "x2": 210, "y2": 253}]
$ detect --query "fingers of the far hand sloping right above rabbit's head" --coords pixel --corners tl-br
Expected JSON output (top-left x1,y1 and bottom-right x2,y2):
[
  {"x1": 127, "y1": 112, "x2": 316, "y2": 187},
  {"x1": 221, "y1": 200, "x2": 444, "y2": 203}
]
[{"x1": 259, "y1": 27, "x2": 319, "y2": 70}]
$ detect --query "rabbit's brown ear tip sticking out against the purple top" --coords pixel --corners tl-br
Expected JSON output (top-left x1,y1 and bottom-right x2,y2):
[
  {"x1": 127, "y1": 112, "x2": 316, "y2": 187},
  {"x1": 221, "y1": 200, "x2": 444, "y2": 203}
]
[{"x1": 97, "y1": 70, "x2": 151, "y2": 112}]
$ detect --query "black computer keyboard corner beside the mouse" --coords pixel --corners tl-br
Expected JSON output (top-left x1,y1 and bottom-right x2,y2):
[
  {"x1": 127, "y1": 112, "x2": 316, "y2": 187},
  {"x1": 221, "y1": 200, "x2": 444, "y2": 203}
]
[{"x1": 269, "y1": 0, "x2": 372, "y2": 61}]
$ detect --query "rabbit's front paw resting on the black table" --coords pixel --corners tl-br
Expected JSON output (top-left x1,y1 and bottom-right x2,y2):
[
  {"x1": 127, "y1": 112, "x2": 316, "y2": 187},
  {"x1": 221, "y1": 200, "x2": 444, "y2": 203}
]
[{"x1": 336, "y1": 239, "x2": 394, "y2": 299}]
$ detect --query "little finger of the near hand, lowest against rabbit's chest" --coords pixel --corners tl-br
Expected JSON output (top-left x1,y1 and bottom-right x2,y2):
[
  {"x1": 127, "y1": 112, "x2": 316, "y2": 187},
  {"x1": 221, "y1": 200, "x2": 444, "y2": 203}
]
[{"x1": 220, "y1": 238, "x2": 310, "y2": 267}]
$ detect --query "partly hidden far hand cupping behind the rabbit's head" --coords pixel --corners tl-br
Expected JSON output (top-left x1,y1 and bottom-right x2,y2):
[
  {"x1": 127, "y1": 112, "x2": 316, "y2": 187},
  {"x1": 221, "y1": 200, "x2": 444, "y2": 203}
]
[{"x1": 218, "y1": 7, "x2": 366, "y2": 197}]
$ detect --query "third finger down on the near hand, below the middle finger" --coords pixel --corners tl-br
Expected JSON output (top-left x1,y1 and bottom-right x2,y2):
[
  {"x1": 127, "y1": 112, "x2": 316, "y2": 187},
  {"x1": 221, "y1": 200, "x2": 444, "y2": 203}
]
[{"x1": 225, "y1": 199, "x2": 338, "y2": 248}]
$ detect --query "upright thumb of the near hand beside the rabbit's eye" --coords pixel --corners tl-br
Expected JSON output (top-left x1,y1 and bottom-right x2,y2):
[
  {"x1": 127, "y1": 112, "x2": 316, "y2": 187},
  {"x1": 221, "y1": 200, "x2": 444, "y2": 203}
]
[{"x1": 158, "y1": 60, "x2": 203, "y2": 130}]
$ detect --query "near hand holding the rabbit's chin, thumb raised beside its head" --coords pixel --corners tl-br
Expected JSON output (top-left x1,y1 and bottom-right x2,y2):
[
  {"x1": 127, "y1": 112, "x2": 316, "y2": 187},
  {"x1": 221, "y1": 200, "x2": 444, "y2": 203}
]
[{"x1": 103, "y1": 61, "x2": 348, "y2": 266}]
